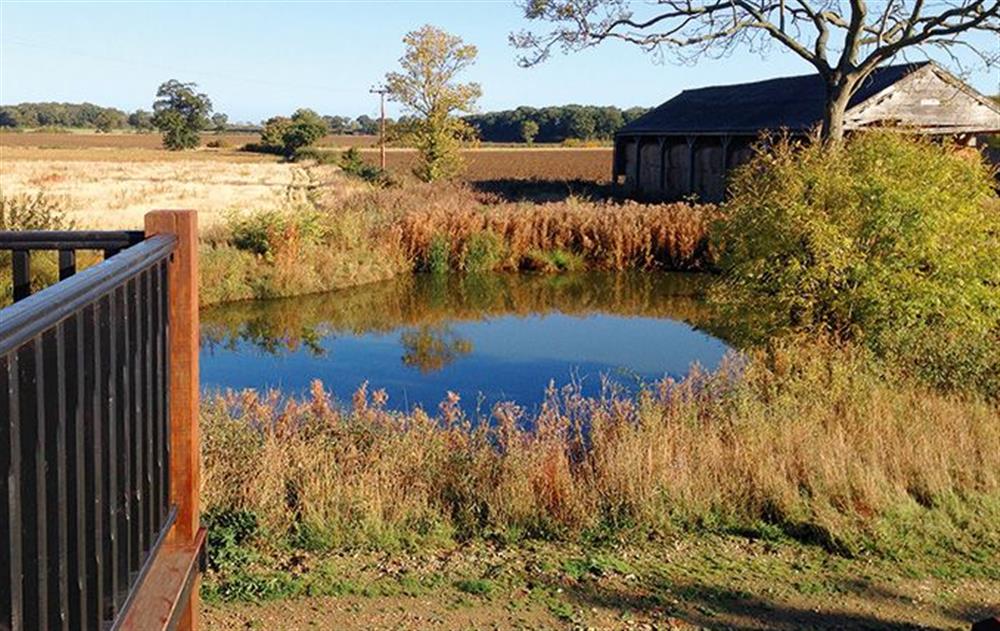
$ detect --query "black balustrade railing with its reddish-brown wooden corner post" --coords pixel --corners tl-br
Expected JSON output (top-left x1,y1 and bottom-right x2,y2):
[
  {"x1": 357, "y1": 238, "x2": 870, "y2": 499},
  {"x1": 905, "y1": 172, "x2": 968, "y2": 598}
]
[{"x1": 0, "y1": 211, "x2": 204, "y2": 630}]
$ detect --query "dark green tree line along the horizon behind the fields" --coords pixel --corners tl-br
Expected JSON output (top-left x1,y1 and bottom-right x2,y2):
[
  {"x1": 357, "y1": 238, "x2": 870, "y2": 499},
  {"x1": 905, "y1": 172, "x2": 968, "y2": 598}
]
[{"x1": 0, "y1": 102, "x2": 649, "y2": 143}]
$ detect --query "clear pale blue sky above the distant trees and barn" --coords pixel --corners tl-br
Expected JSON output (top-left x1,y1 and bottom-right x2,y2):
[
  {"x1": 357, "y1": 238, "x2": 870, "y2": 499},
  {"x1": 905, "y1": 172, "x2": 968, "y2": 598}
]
[{"x1": 0, "y1": 0, "x2": 1000, "y2": 121}]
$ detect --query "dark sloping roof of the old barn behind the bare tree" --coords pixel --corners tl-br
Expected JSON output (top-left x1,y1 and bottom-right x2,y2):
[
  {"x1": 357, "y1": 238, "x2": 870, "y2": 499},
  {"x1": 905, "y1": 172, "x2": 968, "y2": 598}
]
[{"x1": 619, "y1": 62, "x2": 929, "y2": 134}]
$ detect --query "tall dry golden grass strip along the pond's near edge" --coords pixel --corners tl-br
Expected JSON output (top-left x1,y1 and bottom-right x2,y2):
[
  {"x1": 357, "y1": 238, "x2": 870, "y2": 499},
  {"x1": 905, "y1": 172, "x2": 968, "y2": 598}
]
[{"x1": 202, "y1": 343, "x2": 1000, "y2": 552}]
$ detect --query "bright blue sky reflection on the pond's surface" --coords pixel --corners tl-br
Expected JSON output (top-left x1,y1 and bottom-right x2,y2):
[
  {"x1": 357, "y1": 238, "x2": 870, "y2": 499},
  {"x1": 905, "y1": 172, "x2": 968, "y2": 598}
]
[{"x1": 201, "y1": 314, "x2": 726, "y2": 410}]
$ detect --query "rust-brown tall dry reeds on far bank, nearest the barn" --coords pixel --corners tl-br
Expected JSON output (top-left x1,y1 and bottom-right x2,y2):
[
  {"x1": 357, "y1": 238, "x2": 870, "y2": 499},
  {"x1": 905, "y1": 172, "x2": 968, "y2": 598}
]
[{"x1": 360, "y1": 185, "x2": 715, "y2": 270}]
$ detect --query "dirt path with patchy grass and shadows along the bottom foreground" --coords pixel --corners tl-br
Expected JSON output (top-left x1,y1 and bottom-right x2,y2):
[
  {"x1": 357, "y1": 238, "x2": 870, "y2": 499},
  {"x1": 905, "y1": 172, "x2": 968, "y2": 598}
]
[{"x1": 203, "y1": 538, "x2": 1000, "y2": 630}]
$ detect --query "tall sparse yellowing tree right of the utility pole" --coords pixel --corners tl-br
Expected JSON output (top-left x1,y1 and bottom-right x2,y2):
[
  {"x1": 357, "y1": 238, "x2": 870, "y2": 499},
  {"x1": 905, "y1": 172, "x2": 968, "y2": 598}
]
[{"x1": 385, "y1": 25, "x2": 482, "y2": 181}]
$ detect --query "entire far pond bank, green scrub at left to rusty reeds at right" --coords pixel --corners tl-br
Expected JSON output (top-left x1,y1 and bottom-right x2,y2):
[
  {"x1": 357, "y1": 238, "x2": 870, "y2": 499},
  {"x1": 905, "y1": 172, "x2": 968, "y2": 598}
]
[{"x1": 195, "y1": 171, "x2": 716, "y2": 305}]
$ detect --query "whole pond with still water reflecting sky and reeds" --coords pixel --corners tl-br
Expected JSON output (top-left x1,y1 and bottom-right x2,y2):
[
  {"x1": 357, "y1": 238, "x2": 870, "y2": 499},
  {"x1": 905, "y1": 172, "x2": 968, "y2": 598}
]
[{"x1": 201, "y1": 273, "x2": 728, "y2": 412}]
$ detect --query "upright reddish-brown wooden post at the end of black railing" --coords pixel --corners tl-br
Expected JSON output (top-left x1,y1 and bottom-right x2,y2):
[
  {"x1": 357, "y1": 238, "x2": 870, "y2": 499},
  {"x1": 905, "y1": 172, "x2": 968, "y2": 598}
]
[{"x1": 146, "y1": 210, "x2": 201, "y2": 629}]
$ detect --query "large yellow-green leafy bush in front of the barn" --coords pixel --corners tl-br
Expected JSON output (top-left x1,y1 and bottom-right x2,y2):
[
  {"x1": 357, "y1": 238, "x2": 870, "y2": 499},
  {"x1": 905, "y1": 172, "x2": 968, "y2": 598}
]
[{"x1": 714, "y1": 132, "x2": 1000, "y2": 394}]
